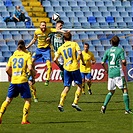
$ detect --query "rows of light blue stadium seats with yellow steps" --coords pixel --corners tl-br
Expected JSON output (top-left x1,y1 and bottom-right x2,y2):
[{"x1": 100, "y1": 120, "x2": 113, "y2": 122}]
[{"x1": 0, "y1": 0, "x2": 133, "y2": 61}]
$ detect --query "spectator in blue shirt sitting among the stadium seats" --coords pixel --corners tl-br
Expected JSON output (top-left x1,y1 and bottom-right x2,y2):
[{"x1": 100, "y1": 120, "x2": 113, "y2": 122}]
[{"x1": 13, "y1": 6, "x2": 25, "y2": 22}]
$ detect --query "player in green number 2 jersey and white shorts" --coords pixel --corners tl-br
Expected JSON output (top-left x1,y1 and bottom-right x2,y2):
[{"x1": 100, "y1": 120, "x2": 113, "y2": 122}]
[{"x1": 101, "y1": 36, "x2": 132, "y2": 114}]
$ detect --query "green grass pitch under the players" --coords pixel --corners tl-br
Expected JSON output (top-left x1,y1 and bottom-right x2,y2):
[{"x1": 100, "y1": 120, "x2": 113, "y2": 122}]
[{"x1": 0, "y1": 82, "x2": 133, "y2": 133}]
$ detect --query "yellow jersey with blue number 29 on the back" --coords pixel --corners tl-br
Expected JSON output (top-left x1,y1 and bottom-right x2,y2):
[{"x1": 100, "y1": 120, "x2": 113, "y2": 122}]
[{"x1": 7, "y1": 50, "x2": 32, "y2": 84}]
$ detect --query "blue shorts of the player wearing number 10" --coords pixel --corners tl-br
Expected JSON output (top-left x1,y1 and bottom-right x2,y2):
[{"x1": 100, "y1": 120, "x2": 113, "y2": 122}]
[{"x1": 64, "y1": 69, "x2": 82, "y2": 87}]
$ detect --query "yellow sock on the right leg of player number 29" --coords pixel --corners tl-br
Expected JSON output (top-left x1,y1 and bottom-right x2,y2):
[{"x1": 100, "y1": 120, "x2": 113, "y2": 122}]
[{"x1": 22, "y1": 102, "x2": 30, "y2": 122}]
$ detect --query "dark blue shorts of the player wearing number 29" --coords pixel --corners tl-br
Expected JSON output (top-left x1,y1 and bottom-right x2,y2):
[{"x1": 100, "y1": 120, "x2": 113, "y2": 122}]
[{"x1": 7, "y1": 82, "x2": 31, "y2": 98}]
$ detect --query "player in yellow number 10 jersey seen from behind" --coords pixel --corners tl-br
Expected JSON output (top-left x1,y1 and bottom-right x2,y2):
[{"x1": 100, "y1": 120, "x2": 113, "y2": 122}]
[{"x1": 54, "y1": 32, "x2": 84, "y2": 112}]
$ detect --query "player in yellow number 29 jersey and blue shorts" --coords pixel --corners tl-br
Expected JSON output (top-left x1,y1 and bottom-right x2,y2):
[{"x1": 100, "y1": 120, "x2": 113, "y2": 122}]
[{"x1": 0, "y1": 40, "x2": 34, "y2": 124}]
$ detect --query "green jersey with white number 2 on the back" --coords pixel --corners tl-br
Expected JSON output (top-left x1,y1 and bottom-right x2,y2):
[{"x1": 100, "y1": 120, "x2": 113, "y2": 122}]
[{"x1": 102, "y1": 47, "x2": 125, "y2": 78}]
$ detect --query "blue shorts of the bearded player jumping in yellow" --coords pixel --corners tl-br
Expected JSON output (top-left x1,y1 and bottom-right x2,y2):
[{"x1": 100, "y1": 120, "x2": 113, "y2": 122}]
[{"x1": 32, "y1": 47, "x2": 51, "y2": 62}]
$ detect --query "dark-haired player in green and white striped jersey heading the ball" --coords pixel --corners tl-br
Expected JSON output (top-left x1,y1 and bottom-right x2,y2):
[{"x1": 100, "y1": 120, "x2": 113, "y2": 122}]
[{"x1": 49, "y1": 20, "x2": 64, "y2": 81}]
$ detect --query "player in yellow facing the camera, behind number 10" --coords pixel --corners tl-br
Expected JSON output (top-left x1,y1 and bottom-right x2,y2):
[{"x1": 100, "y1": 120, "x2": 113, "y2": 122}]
[{"x1": 78, "y1": 43, "x2": 96, "y2": 95}]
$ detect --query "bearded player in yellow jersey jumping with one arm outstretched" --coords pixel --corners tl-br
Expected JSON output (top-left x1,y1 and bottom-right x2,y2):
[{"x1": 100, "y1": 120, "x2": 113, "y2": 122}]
[{"x1": 26, "y1": 21, "x2": 62, "y2": 86}]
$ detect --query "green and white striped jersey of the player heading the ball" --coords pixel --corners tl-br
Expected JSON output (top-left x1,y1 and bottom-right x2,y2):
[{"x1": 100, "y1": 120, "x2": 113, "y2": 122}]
[{"x1": 49, "y1": 32, "x2": 64, "y2": 52}]
